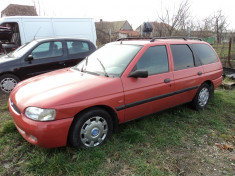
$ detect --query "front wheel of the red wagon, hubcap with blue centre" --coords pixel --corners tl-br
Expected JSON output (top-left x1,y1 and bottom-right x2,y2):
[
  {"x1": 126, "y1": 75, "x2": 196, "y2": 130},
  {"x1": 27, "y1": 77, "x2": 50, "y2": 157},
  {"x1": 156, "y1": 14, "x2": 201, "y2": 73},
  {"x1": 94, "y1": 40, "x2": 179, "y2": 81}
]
[{"x1": 69, "y1": 108, "x2": 113, "y2": 148}]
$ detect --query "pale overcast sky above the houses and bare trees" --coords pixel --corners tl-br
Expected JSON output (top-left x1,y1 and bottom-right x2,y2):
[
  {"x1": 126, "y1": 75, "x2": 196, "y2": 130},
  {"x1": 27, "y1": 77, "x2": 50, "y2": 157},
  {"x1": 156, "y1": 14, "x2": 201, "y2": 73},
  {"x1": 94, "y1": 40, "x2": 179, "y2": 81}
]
[{"x1": 0, "y1": 0, "x2": 235, "y2": 30}]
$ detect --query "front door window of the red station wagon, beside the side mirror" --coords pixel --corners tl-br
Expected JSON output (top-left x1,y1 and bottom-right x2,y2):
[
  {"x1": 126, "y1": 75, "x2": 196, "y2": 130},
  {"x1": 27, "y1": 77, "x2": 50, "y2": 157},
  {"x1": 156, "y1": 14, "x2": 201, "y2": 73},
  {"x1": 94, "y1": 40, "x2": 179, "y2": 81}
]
[{"x1": 133, "y1": 46, "x2": 169, "y2": 75}]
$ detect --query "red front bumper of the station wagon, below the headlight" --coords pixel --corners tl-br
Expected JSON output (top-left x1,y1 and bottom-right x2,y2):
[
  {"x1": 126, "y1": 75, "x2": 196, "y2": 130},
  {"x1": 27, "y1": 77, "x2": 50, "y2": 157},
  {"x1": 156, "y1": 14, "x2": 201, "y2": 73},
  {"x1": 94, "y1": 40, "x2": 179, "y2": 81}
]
[{"x1": 8, "y1": 99, "x2": 73, "y2": 148}]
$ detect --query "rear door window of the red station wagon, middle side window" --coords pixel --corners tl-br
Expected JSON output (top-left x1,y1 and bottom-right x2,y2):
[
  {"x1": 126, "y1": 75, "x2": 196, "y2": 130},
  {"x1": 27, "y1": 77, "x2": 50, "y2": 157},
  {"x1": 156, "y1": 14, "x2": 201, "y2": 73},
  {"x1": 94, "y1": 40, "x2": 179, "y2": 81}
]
[{"x1": 171, "y1": 45, "x2": 194, "y2": 71}]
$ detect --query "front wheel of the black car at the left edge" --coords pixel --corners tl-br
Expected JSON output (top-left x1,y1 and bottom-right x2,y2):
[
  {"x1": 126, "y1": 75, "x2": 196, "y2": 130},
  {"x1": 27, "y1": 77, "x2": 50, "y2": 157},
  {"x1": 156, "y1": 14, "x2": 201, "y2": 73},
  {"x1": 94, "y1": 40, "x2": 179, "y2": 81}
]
[{"x1": 0, "y1": 74, "x2": 20, "y2": 94}]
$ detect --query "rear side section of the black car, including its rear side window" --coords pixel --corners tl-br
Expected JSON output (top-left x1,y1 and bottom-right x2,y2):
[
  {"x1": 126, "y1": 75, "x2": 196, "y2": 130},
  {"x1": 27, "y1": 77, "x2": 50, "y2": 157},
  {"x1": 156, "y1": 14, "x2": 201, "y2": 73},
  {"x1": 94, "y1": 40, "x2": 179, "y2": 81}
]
[{"x1": 65, "y1": 40, "x2": 95, "y2": 67}]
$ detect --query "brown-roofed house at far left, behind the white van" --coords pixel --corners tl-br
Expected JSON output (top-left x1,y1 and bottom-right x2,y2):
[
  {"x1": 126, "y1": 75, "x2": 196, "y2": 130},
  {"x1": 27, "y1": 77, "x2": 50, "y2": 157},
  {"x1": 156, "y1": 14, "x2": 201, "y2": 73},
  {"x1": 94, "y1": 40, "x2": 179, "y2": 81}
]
[{"x1": 1, "y1": 4, "x2": 37, "y2": 17}]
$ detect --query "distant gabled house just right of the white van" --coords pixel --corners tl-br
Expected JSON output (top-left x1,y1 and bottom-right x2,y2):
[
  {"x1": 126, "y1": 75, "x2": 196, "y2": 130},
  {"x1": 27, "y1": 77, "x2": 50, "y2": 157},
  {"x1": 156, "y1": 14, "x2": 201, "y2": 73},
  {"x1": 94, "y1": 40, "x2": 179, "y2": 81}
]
[{"x1": 95, "y1": 20, "x2": 139, "y2": 44}]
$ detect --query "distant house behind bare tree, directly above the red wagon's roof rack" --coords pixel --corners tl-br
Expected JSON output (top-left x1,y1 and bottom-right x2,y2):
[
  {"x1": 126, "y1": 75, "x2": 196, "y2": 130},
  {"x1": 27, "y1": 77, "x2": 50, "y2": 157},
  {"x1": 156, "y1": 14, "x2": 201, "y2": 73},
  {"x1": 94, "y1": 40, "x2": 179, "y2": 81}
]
[{"x1": 136, "y1": 22, "x2": 169, "y2": 37}]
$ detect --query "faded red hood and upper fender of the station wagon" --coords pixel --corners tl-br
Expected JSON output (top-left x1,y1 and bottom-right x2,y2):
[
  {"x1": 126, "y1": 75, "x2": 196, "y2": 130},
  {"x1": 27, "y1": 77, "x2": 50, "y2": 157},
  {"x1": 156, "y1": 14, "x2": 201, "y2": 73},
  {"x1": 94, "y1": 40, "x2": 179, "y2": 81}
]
[{"x1": 10, "y1": 69, "x2": 123, "y2": 109}]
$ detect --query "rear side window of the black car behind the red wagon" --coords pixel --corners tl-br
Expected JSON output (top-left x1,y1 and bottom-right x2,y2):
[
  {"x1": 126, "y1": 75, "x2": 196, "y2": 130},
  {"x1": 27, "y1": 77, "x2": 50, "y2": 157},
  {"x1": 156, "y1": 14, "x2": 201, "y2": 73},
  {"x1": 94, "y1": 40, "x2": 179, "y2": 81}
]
[{"x1": 66, "y1": 41, "x2": 89, "y2": 54}]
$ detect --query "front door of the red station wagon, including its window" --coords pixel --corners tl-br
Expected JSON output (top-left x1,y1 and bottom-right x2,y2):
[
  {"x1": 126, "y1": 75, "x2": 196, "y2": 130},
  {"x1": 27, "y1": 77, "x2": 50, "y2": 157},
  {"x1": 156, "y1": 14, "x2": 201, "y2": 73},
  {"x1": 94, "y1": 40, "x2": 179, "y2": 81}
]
[{"x1": 122, "y1": 45, "x2": 174, "y2": 121}]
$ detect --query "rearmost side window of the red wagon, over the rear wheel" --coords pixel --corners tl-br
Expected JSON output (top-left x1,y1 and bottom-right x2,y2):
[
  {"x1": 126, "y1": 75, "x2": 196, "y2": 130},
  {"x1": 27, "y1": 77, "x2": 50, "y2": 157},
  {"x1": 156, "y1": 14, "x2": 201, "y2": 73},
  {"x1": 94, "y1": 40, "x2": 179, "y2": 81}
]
[{"x1": 190, "y1": 44, "x2": 218, "y2": 65}]
